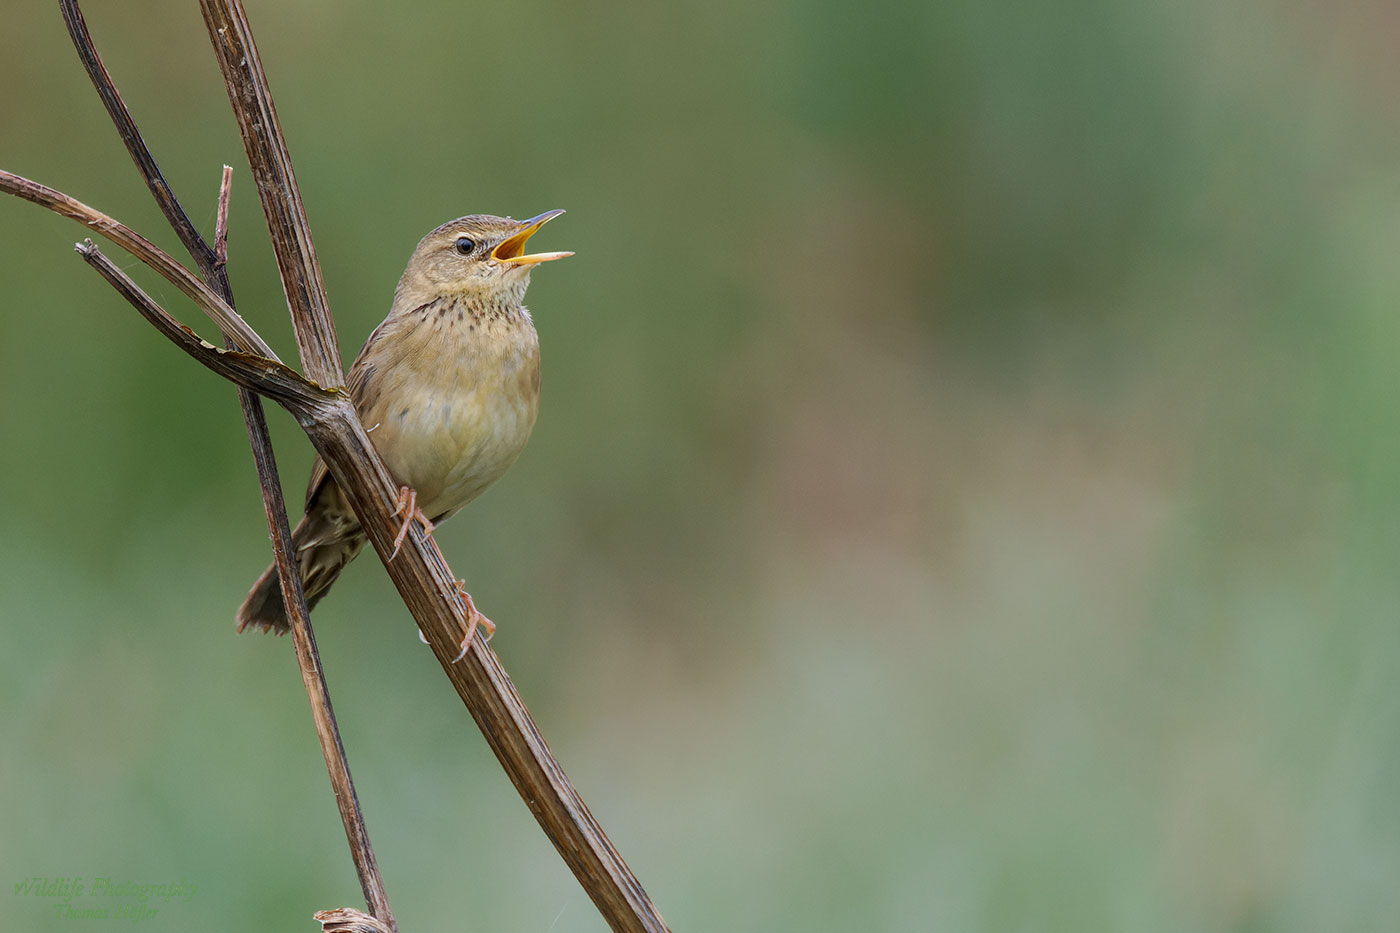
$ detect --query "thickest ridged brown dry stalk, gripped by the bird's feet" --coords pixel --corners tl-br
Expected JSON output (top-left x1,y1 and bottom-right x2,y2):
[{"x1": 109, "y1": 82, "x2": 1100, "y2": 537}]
[{"x1": 200, "y1": 0, "x2": 666, "y2": 930}]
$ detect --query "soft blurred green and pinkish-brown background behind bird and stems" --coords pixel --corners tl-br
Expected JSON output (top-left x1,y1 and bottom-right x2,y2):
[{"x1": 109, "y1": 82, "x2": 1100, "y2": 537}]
[{"x1": 0, "y1": 0, "x2": 1400, "y2": 933}]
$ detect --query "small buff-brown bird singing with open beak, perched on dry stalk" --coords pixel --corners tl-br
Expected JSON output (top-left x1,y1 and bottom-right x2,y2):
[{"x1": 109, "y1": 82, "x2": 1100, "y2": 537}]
[{"x1": 237, "y1": 210, "x2": 574, "y2": 635}]
